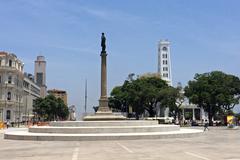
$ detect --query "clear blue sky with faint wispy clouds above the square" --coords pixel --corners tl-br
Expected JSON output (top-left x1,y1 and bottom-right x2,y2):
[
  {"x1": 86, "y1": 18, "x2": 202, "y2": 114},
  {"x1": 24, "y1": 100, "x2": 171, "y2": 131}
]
[{"x1": 0, "y1": 0, "x2": 240, "y2": 114}]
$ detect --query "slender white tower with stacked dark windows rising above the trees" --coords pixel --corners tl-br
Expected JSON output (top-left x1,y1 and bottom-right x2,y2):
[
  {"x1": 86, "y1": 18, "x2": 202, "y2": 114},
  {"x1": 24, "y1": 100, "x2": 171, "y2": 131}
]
[{"x1": 158, "y1": 40, "x2": 172, "y2": 86}]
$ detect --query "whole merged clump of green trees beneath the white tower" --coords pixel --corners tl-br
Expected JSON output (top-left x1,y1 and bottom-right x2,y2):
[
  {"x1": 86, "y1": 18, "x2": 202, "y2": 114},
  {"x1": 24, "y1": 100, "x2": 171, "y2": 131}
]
[{"x1": 109, "y1": 74, "x2": 179, "y2": 119}]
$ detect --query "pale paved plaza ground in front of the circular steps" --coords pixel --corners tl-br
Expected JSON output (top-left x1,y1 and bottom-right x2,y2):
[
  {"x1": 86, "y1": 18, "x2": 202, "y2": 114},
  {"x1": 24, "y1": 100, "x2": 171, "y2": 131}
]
[{"x1": 0, "y1": 127, "x2": 240, "y2": 160}]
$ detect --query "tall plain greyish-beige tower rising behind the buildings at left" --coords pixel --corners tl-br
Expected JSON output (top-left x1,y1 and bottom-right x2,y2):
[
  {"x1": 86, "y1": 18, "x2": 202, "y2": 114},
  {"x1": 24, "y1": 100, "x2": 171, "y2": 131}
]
[{"x1": 34, "y1": 56, "x2": 47, "y2": 98}]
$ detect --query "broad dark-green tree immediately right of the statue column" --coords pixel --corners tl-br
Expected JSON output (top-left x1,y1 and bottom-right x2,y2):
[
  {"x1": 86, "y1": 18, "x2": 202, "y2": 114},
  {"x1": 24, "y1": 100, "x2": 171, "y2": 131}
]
[{"x1": 109, "y1": 74, "x2": 168, "y2": 119}]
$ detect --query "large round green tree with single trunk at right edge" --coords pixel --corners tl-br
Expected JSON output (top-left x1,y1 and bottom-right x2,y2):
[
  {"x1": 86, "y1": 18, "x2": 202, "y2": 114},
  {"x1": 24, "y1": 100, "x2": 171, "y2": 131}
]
[{"x1": 185, "y1": 71, "x2": 240, "y2": 125}]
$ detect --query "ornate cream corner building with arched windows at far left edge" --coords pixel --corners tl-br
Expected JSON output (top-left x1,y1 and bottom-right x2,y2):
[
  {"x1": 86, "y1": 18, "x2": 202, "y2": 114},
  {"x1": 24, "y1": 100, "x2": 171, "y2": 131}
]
[{"x1": 0, "y1": 52, "x2": 24, "y2": 122}]
